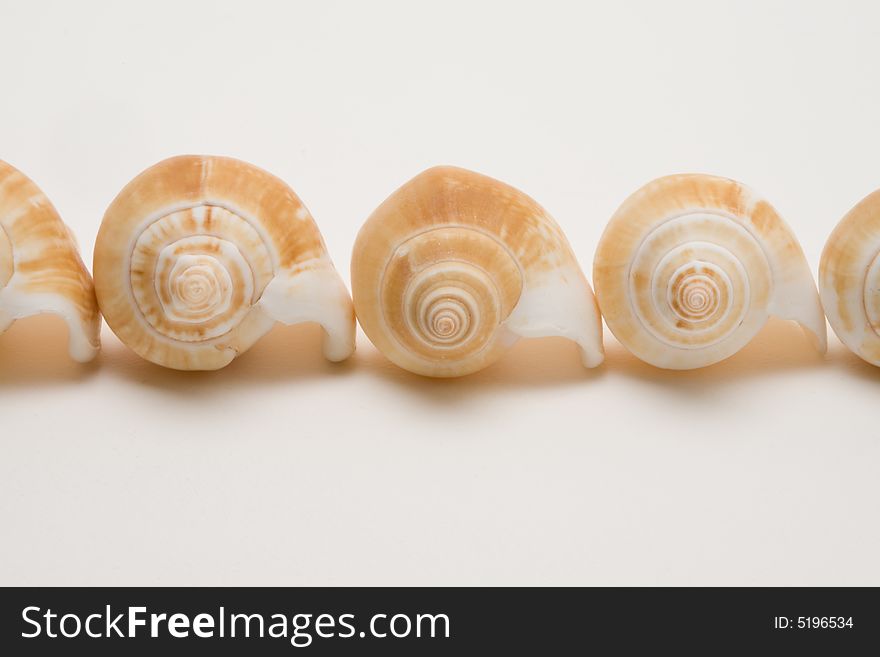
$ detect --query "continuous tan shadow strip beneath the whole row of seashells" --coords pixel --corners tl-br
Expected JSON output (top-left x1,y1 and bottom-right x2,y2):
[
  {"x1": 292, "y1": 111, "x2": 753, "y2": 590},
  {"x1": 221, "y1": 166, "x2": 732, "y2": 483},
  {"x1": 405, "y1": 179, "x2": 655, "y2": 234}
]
[{"x1": 0, "y1": 315, "x2": 868, "y2": 394}]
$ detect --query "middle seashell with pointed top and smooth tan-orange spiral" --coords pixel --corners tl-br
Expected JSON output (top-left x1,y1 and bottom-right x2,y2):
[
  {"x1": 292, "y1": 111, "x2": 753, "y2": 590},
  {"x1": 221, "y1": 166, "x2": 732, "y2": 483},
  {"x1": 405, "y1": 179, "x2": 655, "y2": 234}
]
[{"x1": 351, "y1": 167, "x2": 603, "y2": 377}]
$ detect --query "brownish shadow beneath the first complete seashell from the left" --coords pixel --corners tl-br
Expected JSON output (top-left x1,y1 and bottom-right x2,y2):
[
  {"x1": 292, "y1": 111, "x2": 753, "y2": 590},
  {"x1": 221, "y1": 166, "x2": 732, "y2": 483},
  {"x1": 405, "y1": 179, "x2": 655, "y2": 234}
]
[{"x1": 99, "y1": 323, "x2": 352, "y2": 396}]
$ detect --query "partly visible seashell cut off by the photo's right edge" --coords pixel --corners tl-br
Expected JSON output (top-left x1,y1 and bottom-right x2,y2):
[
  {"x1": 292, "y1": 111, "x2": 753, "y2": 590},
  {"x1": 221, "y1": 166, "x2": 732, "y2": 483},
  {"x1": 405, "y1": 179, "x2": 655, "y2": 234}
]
[{"x1": 819, "y1": 190, "x2": 880, "y2": 366}]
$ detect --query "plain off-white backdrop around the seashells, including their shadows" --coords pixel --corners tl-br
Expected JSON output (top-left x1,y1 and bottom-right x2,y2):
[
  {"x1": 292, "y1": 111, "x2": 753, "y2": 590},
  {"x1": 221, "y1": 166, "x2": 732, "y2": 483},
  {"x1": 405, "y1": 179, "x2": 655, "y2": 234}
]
[{"x1": 0, "y1": 0, "x2": 880, "y2": 585}]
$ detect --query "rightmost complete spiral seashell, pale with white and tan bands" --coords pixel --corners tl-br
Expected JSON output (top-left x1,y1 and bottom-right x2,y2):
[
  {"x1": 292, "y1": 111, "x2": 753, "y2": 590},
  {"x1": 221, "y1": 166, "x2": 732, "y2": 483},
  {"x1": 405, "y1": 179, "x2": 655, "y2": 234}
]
[{"x1": 593, "y1": 174, "x2": 826, "y2": 369}]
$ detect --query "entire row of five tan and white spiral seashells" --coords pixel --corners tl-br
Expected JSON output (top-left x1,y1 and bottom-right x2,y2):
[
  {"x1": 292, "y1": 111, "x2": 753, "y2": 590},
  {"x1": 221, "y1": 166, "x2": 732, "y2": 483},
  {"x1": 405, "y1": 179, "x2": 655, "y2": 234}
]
[{"x1": 0, "y1": 156, "x2": 880, "y2": 377}]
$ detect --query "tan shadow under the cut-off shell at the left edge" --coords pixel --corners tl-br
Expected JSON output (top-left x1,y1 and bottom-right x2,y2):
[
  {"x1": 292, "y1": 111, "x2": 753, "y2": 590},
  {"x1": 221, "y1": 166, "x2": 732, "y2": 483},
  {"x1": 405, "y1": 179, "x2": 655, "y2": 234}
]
[{"x1": 0, "y1": 314, "x2": 98, "y2": 388}]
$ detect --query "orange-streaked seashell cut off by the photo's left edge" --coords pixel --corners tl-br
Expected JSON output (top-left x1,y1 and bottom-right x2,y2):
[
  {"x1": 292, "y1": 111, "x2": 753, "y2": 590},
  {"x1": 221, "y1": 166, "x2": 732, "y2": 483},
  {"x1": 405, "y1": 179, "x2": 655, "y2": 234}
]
[{"x1": 0, "y1": 161, "x2": 101, "y2": 362}]
